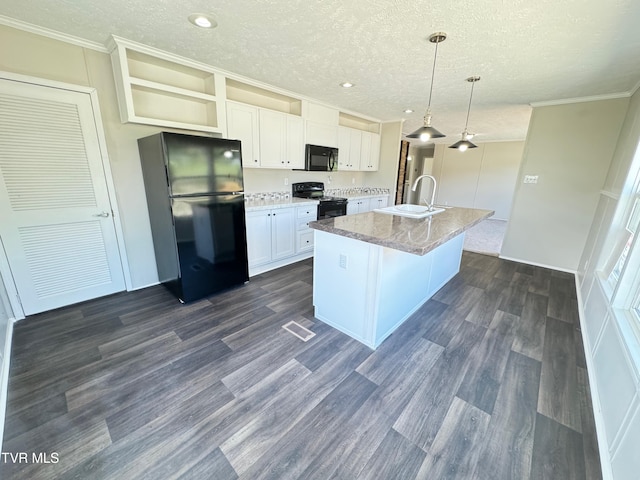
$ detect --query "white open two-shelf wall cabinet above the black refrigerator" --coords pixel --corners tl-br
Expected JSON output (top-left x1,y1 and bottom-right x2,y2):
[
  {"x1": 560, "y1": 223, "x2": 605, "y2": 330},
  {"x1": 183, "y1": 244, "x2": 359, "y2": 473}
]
[{"x1": 109, "y1": 36, "x2": 226, "y2": 133}]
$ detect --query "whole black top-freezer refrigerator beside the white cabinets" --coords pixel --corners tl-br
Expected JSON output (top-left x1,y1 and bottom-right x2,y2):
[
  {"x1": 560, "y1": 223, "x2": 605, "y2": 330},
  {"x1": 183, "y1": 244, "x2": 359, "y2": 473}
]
[{"x1": 138, "y1": 132, "x2": 249, "y2": 302}]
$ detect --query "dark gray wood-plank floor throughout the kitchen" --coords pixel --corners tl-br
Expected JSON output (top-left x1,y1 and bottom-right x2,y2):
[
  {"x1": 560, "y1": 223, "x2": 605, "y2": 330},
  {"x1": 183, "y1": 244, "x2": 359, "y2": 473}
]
[{"x1": 0, "y1": 252, "x2": 601, "y2": 480}]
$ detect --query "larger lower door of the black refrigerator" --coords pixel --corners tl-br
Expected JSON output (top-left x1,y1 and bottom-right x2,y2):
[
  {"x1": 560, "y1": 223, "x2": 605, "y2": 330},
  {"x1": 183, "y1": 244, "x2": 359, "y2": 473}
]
[{"x1": 171, "y1": 195, "x2": 249, "y2": 302}]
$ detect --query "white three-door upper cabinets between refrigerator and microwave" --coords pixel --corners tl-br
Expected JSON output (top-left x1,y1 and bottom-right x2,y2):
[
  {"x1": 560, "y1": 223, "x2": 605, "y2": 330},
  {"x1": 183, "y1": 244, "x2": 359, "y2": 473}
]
[{"x1": 227, "y1": 101, "x2": 304, "y2": 169}]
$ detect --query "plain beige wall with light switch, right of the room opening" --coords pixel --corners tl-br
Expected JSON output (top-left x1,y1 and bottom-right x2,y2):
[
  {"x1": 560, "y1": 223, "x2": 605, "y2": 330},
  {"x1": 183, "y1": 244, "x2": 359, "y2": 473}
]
[{"x1": 501, "y1": 98, "x2": 629, "y2": 271}]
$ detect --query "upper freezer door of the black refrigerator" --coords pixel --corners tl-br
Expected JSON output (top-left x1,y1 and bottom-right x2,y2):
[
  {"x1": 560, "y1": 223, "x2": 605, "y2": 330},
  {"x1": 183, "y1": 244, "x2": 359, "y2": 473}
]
[{"x1": 163, "y1": 132, "x2": 244, "y2": 197}]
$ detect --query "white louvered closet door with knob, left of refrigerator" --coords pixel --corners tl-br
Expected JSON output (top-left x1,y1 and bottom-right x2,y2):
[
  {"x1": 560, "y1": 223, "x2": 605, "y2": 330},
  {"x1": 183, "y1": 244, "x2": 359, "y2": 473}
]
[{"x1": 0, "y1": 79, "x2": 124, "y2": 315}]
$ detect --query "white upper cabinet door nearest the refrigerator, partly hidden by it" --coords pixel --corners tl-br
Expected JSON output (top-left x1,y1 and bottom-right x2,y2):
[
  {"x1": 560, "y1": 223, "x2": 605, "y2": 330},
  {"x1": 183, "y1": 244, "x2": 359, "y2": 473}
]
[{"x1": 227, "y1": 102, "x2": 260, "y2": 168}]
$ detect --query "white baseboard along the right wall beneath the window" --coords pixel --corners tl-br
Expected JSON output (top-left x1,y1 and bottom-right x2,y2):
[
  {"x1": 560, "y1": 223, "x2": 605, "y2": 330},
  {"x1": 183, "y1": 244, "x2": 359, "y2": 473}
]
[{"x1": 576, "y1": 275, "x2": 613, "y2": 480}]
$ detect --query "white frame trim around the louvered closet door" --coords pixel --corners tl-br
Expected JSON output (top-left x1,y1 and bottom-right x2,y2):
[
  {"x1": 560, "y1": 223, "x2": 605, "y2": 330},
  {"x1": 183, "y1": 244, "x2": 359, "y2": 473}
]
[{"x1": 0, "y1": 70, "x2": 132, "y2": 320}]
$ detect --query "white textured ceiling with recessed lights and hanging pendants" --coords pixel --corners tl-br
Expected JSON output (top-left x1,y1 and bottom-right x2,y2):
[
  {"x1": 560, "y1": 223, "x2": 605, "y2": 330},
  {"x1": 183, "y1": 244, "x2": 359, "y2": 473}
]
[{"x1": 0, "y1": 0, "x2": 640, "y2": 143}]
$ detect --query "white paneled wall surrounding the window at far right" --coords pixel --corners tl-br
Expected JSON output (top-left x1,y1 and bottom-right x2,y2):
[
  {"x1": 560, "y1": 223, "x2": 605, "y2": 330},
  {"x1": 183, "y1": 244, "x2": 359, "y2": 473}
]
[{"x1": 577, "y1": 87, "x2": 640, "y2": 480}]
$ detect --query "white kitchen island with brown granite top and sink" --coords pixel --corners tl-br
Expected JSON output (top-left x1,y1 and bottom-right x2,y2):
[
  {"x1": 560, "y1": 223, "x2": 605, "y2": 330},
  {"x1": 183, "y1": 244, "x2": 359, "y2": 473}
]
[{"x1": 309, "y1": 207, "x2": 494, "y2": 349}]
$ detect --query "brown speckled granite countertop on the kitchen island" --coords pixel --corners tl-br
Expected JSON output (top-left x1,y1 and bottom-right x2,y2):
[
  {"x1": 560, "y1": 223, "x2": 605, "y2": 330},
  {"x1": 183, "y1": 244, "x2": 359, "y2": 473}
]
[{"x1": 309, "y1": 207, "x2": 495, "y2": 255}]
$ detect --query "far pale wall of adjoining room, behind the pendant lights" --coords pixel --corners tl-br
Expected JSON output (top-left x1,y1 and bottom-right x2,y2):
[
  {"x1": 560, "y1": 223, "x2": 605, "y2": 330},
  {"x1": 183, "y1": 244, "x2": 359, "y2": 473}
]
[{"x1": 433, "y1": 142, "x2": 524, "y2": 220}]
